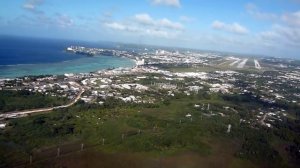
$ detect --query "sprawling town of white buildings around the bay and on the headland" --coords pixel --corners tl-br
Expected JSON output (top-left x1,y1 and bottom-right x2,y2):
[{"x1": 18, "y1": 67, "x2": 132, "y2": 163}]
[{"x1": 0, "y1": 46, "x2": 300, "y2": 130}]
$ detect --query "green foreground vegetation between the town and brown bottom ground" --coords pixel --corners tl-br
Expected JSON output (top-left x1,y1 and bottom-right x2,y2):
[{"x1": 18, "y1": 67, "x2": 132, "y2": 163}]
[{"x1": 0, "y1": 92, "x2": 300, "y2": 167}]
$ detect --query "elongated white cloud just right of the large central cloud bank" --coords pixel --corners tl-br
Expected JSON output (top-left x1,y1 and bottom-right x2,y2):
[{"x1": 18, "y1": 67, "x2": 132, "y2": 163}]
[{"x1": 211, "y1": 20, "x2": 249, "y2": 34}]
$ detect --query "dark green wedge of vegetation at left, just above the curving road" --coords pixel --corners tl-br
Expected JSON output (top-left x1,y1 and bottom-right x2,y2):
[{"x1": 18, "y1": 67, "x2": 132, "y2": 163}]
[{"x1": 0, "y1": 90, "x2": 67, "y2": 113}]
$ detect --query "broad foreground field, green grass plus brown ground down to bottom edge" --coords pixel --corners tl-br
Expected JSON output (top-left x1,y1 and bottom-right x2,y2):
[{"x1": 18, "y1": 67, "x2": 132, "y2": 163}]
[{"x1": 0, "y1": 92, "x2": 298, "y2": 167}]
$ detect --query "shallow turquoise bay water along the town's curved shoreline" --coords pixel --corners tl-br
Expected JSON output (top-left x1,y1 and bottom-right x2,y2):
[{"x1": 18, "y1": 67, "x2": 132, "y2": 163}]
[{"x1": 0, "y1": 56, "x2": 135, "y2": 78}]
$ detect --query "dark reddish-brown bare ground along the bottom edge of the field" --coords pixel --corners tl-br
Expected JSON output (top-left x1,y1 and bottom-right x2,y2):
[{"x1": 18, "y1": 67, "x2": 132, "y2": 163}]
[{"x1": 29, "y1": 136, "x2": 257, "y2": 168}]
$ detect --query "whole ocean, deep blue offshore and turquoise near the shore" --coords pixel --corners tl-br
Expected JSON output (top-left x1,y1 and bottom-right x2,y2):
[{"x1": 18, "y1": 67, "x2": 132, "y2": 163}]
[{"x1": 0, "y1": 36, "x2": 135, "y2": 78}]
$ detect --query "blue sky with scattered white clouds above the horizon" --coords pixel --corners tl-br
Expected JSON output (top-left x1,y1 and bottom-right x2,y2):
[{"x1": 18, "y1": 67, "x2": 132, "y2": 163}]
[{"x1": 0, "y1": 0, "x2": 300, "y2": 58}]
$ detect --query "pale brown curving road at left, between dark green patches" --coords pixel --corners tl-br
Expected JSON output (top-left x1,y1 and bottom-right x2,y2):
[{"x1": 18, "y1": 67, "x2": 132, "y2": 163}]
[{"x1": 0, "y1": 85, "x2": 85, "y2": 119}]
